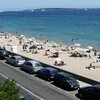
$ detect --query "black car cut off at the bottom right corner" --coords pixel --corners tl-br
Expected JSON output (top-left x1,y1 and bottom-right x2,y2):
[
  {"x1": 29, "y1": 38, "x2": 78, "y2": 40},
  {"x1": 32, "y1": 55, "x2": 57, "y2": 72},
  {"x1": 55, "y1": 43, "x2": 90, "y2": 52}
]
[{"x1": 78, "y1": 85, "x2": 100, "y2": 100}]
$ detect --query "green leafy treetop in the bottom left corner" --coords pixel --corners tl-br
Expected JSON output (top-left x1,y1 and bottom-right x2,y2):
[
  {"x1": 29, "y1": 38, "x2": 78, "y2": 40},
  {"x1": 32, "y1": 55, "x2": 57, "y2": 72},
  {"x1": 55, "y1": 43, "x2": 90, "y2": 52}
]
[{"x1": 0, "y1": 79, "x2": 20, "y2": 100}]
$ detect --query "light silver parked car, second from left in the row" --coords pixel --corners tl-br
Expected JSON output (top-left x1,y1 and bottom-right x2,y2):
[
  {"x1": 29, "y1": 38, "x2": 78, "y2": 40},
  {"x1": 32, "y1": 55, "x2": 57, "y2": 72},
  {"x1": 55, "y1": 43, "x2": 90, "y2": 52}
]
[{"x1": 6, "y1": 55, "x2": 25, "y2": 66}]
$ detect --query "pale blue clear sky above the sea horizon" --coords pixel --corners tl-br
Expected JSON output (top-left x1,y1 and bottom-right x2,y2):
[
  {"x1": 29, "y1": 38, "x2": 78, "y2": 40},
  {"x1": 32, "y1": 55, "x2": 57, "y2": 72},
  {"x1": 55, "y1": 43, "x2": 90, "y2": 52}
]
[{"x1": 0, "y1": 0, "x2": 100, "y2": 11}]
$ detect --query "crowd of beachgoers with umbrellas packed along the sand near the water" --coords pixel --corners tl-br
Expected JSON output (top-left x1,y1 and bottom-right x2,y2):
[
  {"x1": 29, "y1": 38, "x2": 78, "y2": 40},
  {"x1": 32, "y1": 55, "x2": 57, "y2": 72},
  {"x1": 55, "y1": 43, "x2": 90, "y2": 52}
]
[{"x1": 0, "y1": 33, "x2": 100, "y2": 66}]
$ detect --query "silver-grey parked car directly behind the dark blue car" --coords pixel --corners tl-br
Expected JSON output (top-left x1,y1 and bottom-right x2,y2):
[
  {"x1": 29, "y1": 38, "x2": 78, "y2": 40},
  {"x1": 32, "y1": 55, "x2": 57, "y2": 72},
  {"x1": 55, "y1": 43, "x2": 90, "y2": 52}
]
[{"x1": 21, "y1": 60, "x2": 43, "y2": 74}]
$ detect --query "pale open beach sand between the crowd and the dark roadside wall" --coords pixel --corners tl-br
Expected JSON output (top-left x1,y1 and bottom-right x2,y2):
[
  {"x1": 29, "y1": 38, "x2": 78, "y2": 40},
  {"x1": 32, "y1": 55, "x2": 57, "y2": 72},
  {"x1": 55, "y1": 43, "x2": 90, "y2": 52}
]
[{"x1": 0, "y1": 32, "x2": 100, "y2": 82}]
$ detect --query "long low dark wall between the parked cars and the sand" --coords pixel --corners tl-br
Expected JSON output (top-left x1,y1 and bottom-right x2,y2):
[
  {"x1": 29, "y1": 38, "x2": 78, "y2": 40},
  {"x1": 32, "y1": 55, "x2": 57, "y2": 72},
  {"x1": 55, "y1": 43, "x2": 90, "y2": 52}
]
[{"x1": 7, "y1": 51, "x2": 100, "y2": 85}]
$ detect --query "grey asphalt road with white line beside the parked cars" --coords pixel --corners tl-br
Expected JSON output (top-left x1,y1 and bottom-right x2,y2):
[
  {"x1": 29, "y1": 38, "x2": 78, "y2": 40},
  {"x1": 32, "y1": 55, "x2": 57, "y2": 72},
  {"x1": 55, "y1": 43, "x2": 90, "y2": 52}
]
[{"x1": 0, "y1": 61, "x2": 90, "y2": 100}]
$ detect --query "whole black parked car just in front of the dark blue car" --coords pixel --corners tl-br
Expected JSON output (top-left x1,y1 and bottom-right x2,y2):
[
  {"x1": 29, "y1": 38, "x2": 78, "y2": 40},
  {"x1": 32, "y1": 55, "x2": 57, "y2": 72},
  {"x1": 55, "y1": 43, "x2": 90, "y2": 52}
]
[{"x1": 54, "y1": 72, "x2": 80, "y2": 89}]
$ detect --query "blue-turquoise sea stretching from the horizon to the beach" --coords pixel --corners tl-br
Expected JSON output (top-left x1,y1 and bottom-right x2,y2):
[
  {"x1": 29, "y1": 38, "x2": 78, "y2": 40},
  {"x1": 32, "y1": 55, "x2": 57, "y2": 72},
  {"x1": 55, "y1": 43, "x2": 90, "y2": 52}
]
[{"x1": 0, "y1": 8, "x2": 100, "y2": 49}]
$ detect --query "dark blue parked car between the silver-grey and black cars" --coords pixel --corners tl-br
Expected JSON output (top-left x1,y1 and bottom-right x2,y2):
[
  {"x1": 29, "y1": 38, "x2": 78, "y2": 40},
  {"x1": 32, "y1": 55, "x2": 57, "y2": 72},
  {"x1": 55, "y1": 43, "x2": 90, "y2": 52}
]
[{"x1": 37, "y1": 67, "x2": 58, "y2": 80}]
